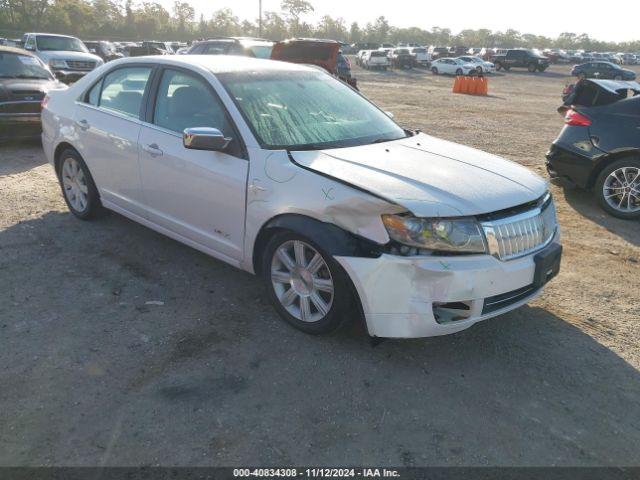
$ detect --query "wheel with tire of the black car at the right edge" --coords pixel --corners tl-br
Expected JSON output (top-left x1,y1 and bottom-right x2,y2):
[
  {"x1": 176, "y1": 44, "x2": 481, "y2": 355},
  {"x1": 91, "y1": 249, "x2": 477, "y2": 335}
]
[{"x1": 594, "y1": 157, "x2": 640, "y2": 220}]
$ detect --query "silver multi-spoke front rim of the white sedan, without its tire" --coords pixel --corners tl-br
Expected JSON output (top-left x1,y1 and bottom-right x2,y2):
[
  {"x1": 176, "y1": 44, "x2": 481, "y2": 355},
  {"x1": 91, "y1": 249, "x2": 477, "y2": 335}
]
[{"x1": 271, "y1": 240, "x2": 334, "y2": 323}]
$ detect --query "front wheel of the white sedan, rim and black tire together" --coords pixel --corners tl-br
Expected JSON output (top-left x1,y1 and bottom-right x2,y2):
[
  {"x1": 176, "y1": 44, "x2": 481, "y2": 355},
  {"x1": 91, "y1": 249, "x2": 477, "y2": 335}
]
[{"x1": 262, "y1": 231, "x2": 358, "y2": 335}]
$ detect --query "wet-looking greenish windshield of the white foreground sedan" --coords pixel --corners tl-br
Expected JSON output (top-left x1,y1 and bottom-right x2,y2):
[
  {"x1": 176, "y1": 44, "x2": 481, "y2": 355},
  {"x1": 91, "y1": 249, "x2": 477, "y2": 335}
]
[{"x1": 217, "y1": 71, "x2": 407, "y2": 150}]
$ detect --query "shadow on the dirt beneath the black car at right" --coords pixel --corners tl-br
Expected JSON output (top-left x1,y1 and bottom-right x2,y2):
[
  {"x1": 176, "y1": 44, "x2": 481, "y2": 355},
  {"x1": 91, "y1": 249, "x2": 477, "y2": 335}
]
[{"x1": 563, "y1": 187, "x2": 640, "y2": 246}]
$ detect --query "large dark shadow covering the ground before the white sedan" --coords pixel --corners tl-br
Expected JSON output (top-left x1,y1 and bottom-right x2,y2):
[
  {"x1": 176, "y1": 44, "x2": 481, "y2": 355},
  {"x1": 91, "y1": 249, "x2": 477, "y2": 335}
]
[{"x1": 0, "y1": 212, "x2": 640, "y2": 466}]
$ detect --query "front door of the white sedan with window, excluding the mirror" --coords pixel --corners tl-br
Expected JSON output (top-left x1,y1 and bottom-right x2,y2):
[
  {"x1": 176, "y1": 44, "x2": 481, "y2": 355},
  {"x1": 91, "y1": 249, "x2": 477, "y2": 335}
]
[{"x1": 139, "y1": 68, "x2": 249, "y2": 260}]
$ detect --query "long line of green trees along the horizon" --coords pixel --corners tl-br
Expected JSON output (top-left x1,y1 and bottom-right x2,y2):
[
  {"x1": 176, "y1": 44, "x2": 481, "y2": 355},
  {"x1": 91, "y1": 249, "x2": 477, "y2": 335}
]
[{"x1": 0, "y1": 0, "x2": 640, "y2": 51}]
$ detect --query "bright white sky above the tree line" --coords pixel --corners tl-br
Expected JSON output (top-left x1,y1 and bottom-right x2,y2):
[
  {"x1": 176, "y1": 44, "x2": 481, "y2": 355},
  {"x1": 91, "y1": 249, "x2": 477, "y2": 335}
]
[{"x1": 158, "y1": 0, "x2": 640, "y2": 42}]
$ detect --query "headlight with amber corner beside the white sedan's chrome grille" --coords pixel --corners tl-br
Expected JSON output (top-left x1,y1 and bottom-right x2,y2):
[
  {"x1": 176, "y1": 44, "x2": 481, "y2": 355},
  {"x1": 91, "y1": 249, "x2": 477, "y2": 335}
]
[{"x1": 382, "y1": 214, "x2": 487, "y2": 253}]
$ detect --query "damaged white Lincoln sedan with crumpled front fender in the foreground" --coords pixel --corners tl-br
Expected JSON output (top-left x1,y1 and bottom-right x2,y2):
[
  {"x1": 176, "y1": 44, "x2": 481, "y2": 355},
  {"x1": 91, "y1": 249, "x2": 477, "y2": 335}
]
[{"x1": 42, "y1": 55, "x2": 562, "y2": 338}]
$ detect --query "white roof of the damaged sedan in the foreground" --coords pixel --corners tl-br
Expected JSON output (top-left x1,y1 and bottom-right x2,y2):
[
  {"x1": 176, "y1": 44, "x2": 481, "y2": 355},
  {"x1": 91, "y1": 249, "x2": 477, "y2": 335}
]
[{"x1": 114, "y1": 55, "x2": 315, "y2": 74}]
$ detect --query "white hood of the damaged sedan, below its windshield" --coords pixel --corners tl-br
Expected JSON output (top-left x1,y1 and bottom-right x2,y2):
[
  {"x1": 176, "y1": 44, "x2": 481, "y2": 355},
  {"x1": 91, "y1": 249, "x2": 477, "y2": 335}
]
[{"x1": 291, "y1": 134, "x2": 547, "y2": 217}]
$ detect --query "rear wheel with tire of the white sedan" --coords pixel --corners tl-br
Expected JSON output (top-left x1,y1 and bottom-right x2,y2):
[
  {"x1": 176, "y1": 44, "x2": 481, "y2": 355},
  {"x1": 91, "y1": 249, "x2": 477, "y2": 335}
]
[{"x1": 56, "y1": 149, "x2": 103, "y2": 220}]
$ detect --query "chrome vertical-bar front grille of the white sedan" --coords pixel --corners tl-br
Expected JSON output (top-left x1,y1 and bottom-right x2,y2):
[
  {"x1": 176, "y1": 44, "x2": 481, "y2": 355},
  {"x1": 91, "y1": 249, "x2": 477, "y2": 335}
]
[{"x1": 482, "y1": 198, "x2": 558, "y2": 260}]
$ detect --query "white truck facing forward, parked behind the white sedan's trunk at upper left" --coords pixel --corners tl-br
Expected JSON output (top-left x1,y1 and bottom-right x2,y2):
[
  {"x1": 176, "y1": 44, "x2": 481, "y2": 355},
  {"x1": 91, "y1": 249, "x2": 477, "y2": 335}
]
[{"x1": 22, "y1": 33, "x2": 104, "y2": 83}]
